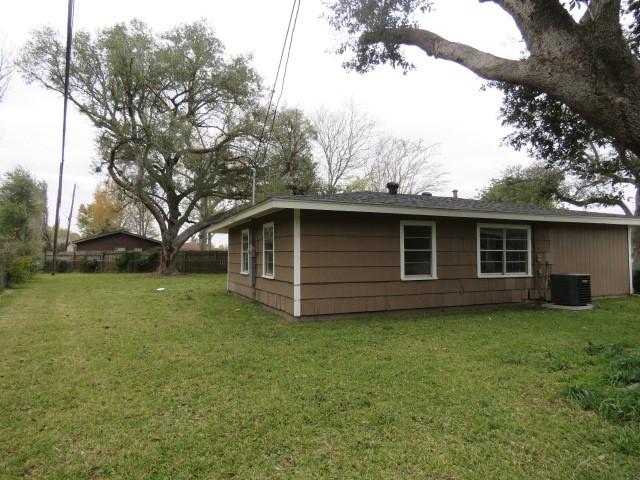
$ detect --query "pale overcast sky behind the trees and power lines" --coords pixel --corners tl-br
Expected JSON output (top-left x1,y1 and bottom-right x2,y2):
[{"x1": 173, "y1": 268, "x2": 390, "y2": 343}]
[{"x1": 0, "y1": 0, "x2": 530, "y2": 233}]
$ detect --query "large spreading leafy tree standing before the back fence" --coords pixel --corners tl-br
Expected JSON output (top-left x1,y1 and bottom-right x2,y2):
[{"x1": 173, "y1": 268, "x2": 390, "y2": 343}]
[{"x1": 20, "y1": 20, "x2": 260, "y2": 274}]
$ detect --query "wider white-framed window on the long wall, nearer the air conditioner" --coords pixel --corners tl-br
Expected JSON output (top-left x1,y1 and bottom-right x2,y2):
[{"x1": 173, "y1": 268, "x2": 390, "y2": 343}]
[{"x1": 478, "y1": 224, "x2": 531, "y2": 277}]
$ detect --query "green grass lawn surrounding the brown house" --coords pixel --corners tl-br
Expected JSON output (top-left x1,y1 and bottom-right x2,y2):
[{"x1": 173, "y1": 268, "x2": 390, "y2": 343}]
[{"x1": 0, "y1": 274, "x2": 640, "y2": 479}]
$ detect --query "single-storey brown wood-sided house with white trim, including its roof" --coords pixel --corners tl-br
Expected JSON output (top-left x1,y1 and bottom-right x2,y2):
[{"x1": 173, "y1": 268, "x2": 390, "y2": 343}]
[{"x1": 211, "y1": 192, "x2": 640, "y2": 317}]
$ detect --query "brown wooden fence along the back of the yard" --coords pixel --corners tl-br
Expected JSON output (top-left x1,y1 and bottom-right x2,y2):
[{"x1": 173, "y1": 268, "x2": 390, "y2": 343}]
[{"x1": 45, "y1": 250, "x2": 227, "y2": 273}]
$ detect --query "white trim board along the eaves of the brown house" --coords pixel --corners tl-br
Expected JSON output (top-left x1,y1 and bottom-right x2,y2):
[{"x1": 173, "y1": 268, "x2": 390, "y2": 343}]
[{"x1": 208, "y1": 199, "x2": 640, "y2": 233}]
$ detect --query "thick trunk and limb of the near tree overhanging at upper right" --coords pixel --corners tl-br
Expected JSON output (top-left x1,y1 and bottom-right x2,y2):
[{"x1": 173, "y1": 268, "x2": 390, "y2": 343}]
[{"x1": 329, "y1": 0, "x2": 640, "y2": 160}]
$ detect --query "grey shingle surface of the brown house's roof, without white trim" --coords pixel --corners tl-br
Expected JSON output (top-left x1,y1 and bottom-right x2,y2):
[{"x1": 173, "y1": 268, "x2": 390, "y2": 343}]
[{"x1": 274, "y1": 192, "x2": 626, "y2": 218}]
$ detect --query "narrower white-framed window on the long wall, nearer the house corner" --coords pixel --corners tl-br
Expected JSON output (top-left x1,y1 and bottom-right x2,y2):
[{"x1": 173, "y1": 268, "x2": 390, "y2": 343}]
[{"x1": 400, "y1": 221, "x2": 437, "y2": 280}]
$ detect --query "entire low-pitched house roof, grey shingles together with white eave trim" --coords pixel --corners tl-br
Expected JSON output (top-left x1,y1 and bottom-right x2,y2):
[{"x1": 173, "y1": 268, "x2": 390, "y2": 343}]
[{"x1": 210, "y1": 192, "x2": 640, "y2": 232}]
